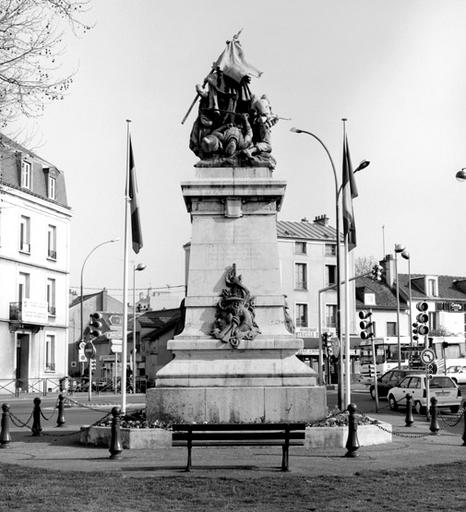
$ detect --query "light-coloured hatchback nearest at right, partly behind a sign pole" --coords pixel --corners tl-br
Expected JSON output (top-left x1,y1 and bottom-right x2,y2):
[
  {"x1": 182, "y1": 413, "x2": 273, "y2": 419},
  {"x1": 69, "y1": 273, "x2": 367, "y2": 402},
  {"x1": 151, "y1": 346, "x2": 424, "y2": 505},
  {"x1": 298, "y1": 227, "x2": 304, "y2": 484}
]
[{"x1": 388, "y1": 375, "x2": 461, "y2": 414}]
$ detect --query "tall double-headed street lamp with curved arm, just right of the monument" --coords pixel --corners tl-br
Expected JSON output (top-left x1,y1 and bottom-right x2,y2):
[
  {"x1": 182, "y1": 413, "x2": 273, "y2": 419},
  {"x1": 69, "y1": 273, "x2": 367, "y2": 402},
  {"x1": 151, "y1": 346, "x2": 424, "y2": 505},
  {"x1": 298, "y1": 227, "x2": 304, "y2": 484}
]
[{"x1": 290, "y1": 127, "x2": 370, "y2": 409}]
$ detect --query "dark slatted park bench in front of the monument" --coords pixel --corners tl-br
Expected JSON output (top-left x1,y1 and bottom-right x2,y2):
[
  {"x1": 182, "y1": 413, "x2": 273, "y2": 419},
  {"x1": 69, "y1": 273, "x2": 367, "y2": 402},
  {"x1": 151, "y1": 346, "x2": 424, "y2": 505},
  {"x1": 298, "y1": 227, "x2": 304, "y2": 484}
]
[{"x1": 172, "y1": 423, "x2": 306, "y2": 471}]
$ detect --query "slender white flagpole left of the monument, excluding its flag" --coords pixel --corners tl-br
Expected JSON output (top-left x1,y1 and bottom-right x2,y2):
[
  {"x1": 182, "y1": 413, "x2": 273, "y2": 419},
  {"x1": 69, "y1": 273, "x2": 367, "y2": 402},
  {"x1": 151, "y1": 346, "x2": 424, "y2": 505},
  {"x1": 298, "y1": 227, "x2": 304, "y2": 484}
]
[{"x1": 121, "y1": 119, "x2": 131, "y2": 414}]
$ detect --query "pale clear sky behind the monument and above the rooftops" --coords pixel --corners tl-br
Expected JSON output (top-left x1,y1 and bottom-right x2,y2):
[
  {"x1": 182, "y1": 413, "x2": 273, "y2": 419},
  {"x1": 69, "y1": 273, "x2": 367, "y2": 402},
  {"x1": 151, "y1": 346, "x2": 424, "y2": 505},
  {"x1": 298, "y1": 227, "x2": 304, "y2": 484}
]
[{"x1": 10, "y1": 0, "x2": 466, "y2": 298}]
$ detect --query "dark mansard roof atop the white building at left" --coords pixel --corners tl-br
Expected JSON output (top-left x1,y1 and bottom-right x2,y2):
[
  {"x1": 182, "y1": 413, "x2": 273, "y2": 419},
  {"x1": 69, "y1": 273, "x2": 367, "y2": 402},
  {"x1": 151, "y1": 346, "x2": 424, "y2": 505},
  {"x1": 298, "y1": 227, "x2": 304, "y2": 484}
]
[{"x1": 0, "y1": 133, "x2": 69, "y2": 208}]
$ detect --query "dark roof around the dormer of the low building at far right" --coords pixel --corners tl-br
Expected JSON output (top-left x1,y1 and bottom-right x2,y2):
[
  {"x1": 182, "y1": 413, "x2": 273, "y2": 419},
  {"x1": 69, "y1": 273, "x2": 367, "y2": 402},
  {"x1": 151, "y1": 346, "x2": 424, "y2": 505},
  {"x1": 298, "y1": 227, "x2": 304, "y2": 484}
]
[{"x1": 398, "y1": 274, "x2": 466, "y2": 301}]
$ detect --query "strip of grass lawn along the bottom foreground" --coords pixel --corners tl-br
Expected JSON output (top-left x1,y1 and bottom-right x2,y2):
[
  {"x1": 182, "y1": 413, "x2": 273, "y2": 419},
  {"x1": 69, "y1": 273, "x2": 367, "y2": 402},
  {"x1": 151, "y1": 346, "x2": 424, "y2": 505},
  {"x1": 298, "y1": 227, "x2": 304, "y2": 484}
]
[{"x1": 0, "y1": 460, "x2": 466, "y2": 512}]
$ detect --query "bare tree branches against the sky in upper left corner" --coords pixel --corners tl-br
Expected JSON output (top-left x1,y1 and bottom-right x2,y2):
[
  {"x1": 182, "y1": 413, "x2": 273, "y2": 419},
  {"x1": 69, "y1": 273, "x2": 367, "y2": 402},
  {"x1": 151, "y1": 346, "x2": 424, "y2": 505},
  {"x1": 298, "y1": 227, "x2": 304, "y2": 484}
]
[{"x1": 0, "y1": 0, "x2": 90, "y2": 126}]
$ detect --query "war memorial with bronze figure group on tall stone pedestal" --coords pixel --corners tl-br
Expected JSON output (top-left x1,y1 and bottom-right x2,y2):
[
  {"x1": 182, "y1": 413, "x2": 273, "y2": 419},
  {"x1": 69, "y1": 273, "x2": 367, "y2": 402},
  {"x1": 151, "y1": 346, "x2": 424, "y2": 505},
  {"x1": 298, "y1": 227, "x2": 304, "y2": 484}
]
[{"x1": 147, "y1": 35, "x2": 326, "y2": 423}]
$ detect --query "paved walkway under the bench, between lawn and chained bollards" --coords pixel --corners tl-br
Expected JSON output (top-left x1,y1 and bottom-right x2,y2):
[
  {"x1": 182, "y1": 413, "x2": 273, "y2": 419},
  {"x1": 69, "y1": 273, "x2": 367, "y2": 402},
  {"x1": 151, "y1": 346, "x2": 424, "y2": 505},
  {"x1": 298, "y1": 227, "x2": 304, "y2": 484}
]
[{"x1": 0, "y1": 406, "x2": 466, "y2": 479}]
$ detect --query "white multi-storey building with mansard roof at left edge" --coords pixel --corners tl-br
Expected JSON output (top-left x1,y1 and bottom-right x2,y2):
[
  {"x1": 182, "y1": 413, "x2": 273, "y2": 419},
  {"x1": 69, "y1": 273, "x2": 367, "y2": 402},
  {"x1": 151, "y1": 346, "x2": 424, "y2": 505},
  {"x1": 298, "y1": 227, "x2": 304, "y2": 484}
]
[{"x1": 0, "y1": 136, "x2": 71, "y2": 392}]
